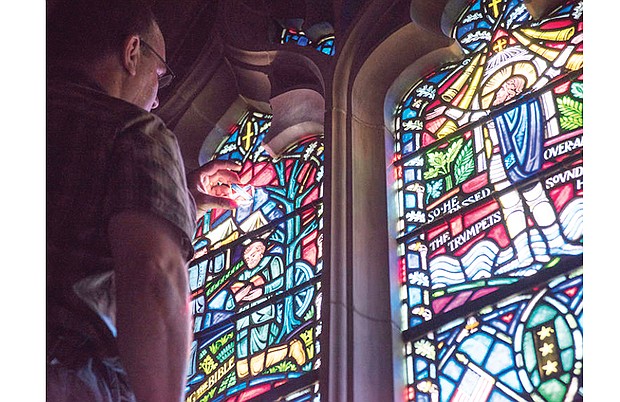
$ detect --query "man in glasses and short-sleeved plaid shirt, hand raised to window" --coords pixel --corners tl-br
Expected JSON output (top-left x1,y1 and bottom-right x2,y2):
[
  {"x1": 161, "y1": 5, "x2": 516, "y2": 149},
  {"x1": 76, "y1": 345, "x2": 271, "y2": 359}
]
[{"x1": 46, "y1": 0, "x2": 238, "y2": 402}]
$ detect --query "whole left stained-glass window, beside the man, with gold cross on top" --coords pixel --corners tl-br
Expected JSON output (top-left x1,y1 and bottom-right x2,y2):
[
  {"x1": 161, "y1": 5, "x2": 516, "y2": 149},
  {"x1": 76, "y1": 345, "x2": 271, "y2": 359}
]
[{"x1": 186, "y1": 112, "x2": 324, "y2": 402}]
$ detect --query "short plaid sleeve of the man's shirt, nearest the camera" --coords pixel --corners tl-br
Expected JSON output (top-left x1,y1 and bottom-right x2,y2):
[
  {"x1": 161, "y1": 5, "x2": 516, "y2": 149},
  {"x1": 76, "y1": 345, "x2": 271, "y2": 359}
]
[{"x1": 106, "y1": 114, "x2": 196, "y2": 260}]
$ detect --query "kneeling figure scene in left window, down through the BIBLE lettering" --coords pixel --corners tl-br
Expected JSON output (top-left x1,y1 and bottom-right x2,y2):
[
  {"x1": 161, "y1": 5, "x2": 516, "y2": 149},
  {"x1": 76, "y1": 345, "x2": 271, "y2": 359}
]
[{"x1": 188, "y1": 208, "x2": 323, "y2": 402}]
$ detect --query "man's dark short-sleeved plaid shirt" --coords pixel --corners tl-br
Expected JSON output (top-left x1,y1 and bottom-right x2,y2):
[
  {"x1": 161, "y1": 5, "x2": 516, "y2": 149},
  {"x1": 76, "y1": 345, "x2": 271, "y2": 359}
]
[{"x1": 46, "y1": 77, "x2": 196, "y2": 332}]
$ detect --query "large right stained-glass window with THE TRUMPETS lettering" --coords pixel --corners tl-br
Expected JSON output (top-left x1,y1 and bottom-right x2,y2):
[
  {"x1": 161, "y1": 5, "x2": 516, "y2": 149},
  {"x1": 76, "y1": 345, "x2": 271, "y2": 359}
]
[{"x1": 394, "y1": 0, "x2": 583, "y2": 402}]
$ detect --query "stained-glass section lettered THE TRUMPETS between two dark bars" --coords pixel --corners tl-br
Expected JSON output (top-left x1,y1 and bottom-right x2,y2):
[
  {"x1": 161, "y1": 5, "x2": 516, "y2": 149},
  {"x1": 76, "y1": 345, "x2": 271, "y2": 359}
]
[{"x1": 401, "y1": 160, "x2": 583, "y2": 328}]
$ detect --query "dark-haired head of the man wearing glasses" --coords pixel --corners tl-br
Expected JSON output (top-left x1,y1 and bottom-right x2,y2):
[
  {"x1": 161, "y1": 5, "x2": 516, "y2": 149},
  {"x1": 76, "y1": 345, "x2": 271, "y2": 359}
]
[{"x1": 47, "y1": 0, "x2": 173, "y2": 111}]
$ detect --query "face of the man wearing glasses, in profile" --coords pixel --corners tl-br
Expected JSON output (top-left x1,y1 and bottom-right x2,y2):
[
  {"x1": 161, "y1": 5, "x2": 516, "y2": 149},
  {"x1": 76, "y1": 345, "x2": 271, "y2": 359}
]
[{"x1": 134, "y1": 26, "x2": 167, "y2": 112}]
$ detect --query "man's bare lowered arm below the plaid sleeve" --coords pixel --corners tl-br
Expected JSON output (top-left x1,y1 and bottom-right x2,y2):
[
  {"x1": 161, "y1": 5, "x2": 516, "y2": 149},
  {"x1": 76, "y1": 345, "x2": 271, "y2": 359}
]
[{"x1": 109, "y1": 211, "x2": 191, "y2": 402}]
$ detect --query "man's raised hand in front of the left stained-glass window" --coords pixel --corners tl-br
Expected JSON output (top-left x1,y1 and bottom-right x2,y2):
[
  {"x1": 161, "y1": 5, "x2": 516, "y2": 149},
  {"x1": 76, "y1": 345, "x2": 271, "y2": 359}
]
[{"x1": 187, "y1": 160, "x2": 241, "y2": 219}]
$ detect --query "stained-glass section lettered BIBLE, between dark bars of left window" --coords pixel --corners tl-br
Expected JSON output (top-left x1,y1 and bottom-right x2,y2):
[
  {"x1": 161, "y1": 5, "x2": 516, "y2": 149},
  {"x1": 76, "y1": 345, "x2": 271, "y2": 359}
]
[{"x1": 187, "y1": 285, "x2": 321, "y2": 402}]
